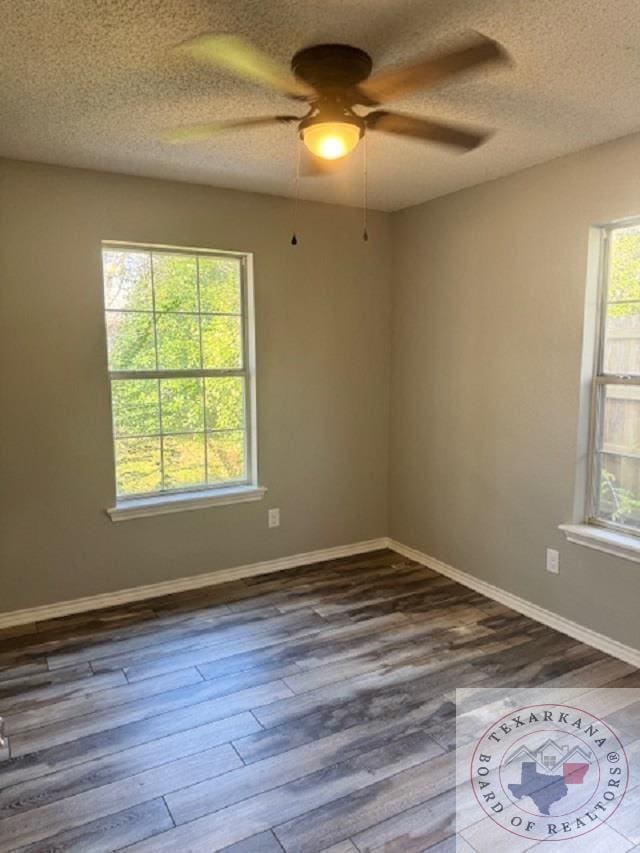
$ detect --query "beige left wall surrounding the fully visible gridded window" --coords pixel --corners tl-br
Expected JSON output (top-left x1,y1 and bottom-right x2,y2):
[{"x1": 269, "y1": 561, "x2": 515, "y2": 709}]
[{"x1": 0, "y1": 160, "x2": 391, "y2": 610}]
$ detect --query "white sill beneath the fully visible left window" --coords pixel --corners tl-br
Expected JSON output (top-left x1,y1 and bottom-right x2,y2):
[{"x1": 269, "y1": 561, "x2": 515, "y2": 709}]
[{"x1": 107, "y1": 486, "x2": 267, "y2": 521}]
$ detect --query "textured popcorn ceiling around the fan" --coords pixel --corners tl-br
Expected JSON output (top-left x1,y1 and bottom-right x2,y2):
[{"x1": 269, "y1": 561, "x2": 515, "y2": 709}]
[{"x1": 0, "y1": 0, "x2": 640, "y2": 210}]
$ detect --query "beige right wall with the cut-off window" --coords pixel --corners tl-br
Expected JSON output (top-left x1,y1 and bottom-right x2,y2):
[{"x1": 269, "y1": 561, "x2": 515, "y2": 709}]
[{"x1": 389, "y1": 131, "x2": 640, "y2": 647}]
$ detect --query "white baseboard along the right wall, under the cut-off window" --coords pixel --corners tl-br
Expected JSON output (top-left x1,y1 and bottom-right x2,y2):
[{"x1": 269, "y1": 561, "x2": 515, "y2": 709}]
[{"x1": 387, "y1": 539, "x2": 640, "y2": 668}]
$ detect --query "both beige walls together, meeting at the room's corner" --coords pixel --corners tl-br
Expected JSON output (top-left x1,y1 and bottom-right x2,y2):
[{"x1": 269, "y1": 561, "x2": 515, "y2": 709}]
[{"x1": 0, "y1": 131, "x2": 640, "y2": 647}]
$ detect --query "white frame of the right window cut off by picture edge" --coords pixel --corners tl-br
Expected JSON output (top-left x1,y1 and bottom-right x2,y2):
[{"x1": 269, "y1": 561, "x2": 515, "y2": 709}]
[{"x1": 585, "y1": 216, "x2": 640, "y2": 539}]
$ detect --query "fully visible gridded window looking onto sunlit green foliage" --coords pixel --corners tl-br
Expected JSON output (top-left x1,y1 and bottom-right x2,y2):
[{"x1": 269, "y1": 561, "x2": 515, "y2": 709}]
[{"x1": 102, "y1": 243, "x2": 256, "y2": 506}]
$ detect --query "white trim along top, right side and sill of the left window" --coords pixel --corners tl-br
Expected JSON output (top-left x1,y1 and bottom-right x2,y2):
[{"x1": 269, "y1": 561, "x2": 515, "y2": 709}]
[{"x1": 102, "y1": 240, "x2": 267, "y2": 522}]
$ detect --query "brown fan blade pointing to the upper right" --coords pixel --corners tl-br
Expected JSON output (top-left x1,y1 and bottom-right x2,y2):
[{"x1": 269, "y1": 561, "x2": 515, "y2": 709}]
[{"x1": 358, "y1": 33, "x2": 508, "y2": 104}]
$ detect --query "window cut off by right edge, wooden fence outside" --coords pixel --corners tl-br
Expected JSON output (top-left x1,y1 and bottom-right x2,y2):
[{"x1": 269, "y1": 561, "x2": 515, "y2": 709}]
[{"x1": 587, "y1": 221, "x2": 640, "y2": 535}]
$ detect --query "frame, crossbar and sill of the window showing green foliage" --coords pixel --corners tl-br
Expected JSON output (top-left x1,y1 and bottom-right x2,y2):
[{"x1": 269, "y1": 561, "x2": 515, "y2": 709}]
[{"x1": 100, "y1": 240, "x2": 266, "y2": 521}]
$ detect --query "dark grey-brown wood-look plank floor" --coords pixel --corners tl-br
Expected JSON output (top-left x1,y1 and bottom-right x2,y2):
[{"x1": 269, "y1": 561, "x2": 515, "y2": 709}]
[{"x1": 0, "y1": 551, "x2": 640, "y2": 853}]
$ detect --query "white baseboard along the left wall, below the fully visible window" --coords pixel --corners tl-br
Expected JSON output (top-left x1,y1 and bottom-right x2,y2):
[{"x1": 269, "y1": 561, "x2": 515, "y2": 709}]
[{"x1": 0, "y1": 537, "x2": 389, "y2": 628}]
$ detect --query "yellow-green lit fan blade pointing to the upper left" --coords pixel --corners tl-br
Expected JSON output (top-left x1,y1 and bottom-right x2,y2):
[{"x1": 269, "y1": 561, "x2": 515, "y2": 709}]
[{"x1": 176, "y1": 33, "x2": 316, "y2": 99}]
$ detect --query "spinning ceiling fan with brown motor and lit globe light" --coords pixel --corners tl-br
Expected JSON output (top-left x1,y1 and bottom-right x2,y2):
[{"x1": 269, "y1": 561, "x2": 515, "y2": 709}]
[{"x1": 163, "y1": 34, "x2": 508, "y2": 169}]
